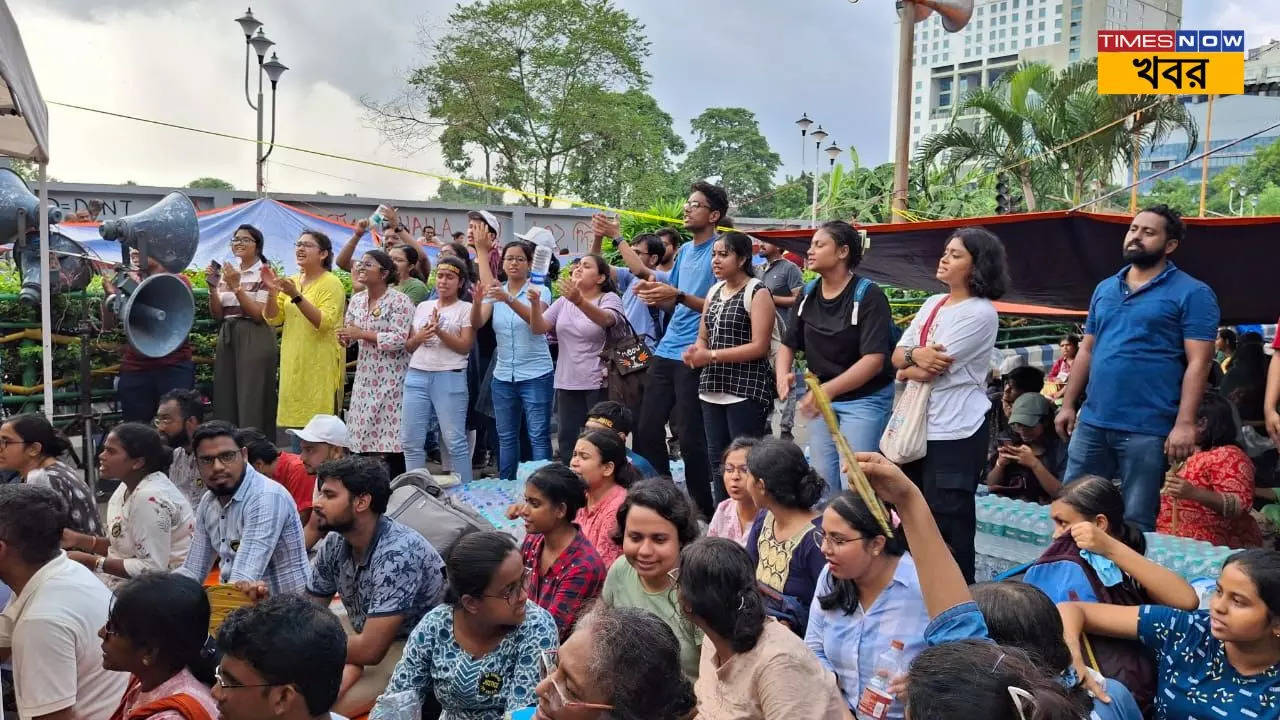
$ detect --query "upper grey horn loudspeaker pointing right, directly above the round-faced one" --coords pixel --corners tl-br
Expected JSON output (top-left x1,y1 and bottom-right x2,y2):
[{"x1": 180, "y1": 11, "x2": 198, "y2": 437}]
[{"x1": 97, "y1": 192, "x2": 200, "y2": 273}]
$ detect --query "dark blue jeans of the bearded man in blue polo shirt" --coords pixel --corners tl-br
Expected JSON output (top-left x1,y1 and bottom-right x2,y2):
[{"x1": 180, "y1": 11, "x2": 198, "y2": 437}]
[{"x1": 1066, "y1": 423, "x2": 1166, "y2": 532}]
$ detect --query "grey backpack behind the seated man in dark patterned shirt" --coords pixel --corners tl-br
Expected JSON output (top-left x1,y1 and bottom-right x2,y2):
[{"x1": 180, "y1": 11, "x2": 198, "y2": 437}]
[{"x1": 385, "y1": 470, "x2": 494, "y2": 557}]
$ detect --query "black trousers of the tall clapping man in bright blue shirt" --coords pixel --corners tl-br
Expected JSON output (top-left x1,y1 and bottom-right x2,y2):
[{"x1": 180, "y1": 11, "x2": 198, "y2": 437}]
[{"x1": 634, "y1": 356, "x2": 716, "y2": 519}]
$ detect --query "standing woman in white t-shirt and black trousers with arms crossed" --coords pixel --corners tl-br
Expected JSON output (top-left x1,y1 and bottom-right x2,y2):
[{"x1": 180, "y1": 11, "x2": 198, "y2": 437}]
[{"x1": 893, "y1": 228, "x2": 1009, "y2": 583}]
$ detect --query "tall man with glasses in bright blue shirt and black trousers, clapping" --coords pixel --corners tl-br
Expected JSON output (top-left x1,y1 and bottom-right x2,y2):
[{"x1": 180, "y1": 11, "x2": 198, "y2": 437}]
[{"x1": 635, "y1": 182, "x2": 728, "y2": 519}]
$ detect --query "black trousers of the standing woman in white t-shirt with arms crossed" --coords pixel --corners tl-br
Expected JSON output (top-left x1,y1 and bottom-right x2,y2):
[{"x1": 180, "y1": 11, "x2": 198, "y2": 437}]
[{"x1": 902, "y1": 420, "x2": 991, "y2": 584}]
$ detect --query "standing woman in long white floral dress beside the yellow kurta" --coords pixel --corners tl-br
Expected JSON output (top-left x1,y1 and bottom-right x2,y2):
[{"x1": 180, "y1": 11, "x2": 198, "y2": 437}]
[{"x1": 338, "y1": 250, "x2": 413, "y2": 477}]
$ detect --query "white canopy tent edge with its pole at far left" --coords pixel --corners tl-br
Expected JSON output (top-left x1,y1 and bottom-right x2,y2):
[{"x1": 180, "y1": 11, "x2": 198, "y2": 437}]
[{"x1": 0, "y1": 0, "x2": 54, "y2": 419}]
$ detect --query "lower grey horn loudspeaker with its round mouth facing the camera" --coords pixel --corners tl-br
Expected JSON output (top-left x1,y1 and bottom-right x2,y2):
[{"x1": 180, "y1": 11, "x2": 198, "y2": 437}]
[{"x1": 119, "y1": 274, "x2": 196, "y2": 357}]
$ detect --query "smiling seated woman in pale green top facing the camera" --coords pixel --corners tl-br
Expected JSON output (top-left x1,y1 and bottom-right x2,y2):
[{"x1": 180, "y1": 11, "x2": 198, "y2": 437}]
[{"x1": 600, "y1": 478, "x2": 703, "y2": 679}]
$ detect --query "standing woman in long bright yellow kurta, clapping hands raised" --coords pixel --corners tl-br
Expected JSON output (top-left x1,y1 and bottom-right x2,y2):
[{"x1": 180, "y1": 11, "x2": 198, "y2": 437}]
[{"x1": 262, "y1": 231, "x2": 347, "y2": 429}]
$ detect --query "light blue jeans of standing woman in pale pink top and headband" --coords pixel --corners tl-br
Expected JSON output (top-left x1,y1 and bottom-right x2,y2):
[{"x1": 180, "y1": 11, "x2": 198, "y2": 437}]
[{"x1": 401, "y1": 368, "x2": 471, "y2": 483}]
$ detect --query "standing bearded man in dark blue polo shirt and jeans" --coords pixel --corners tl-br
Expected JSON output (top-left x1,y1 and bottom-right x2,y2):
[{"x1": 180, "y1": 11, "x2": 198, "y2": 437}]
[{"x1": 1056, "y1": 205, "x2": 1219, "y2": 530}]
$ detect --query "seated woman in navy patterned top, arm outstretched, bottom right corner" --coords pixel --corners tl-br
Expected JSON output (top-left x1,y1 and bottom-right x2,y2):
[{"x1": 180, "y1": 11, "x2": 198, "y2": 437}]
[{"x1": 1054, "y1": 550, "x2": 1280, "y2": 720}]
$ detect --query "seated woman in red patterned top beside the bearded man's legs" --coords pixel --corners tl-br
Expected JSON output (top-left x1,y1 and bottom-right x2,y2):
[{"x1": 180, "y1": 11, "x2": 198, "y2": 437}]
[{"x1": 1156, "y1": 392, "x2": 1262, "y2": 547}]
